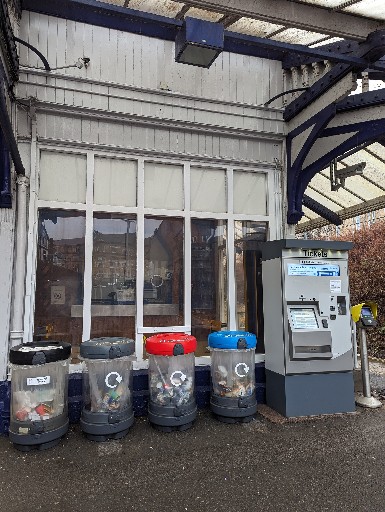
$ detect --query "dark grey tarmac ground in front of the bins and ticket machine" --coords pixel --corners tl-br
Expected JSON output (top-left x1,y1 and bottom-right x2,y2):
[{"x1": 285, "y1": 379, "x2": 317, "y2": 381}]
[{"x1": 0, "y1": 407, "x2": 385, "y2": 512}]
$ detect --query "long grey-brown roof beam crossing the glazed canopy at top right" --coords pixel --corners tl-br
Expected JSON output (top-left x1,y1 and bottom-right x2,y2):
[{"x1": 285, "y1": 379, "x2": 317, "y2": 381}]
[{"x1": 185, "y1": 0, "x2": 385, "y2": 41}]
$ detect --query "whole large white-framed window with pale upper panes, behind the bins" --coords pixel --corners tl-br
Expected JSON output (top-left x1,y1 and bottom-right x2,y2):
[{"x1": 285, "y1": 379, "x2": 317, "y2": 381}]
[{"x1": 30, "y1": 150, "x2": 272, "y2": 360}]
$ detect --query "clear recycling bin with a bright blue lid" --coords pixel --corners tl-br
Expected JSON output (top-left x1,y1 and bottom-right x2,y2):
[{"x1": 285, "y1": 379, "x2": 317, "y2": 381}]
[{"x1": 208, "y1": 331, "x2": 257, "y2": 423}]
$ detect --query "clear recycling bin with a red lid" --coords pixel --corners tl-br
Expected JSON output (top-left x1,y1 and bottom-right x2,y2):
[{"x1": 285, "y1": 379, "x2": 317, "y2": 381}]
[{"x1": 146, "y1": 333, "x2": 197, "y2": 432}]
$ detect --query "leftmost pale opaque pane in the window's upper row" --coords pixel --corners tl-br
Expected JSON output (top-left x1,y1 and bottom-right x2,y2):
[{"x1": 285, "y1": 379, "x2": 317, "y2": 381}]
[{"x1": 39, "y1": 151, "x2": 87, "y2": 203}]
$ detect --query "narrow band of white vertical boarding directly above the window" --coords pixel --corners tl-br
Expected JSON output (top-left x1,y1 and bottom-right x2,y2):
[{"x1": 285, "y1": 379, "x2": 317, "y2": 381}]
[{"x1": 33, "y1": 112, "x2": 281, "y2": 165}]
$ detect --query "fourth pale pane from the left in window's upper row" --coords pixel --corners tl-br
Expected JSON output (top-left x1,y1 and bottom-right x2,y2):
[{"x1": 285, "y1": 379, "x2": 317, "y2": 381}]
[{"x1": 191, "y1": 167, "x2": 227, "y2": 213}]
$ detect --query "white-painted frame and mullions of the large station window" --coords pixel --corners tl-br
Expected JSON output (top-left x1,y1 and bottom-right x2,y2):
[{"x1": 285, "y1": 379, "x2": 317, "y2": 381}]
[{"x1": 24, "y1": 144, "x2": 280, "y2": 368}]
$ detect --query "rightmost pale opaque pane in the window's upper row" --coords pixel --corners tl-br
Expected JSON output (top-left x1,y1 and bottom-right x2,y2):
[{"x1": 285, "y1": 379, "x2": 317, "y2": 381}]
[{"x1": 234, "y1": 171, "x2": 267, "y2": 215}]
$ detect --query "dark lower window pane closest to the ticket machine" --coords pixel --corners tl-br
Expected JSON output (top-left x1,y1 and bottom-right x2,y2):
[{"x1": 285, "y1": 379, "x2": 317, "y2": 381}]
[{"x1": 234, "y1": 221, "x2": 268, "y2": 352}]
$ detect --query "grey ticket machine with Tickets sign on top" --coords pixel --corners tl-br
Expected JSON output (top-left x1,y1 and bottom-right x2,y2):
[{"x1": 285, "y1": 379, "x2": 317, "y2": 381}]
[{"x1": 261, "y1": 239, "x2": 355, "y2": 417}]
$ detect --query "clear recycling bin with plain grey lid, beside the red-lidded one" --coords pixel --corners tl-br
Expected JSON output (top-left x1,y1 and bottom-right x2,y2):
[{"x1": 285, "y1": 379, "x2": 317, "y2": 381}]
[{"x1": 80, "y1": 338, "x2": 135, "y2": 441}]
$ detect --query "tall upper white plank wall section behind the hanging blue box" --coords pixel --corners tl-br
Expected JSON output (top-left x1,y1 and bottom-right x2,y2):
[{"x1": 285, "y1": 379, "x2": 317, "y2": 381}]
[{"x1": 20, "y1": 11, "x2": 282, "y2": 105}]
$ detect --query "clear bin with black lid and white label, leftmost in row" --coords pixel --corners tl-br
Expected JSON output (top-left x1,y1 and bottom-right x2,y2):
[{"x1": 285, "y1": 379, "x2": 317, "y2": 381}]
[{"x1": 9, "y1": 340, "x2": 71, "y2": 452}]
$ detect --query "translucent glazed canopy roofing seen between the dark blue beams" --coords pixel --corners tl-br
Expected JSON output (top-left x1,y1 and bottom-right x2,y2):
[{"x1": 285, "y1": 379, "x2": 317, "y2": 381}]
[{"x1": 97, "y1": 0, "x2": 385, "y2": 232}]
